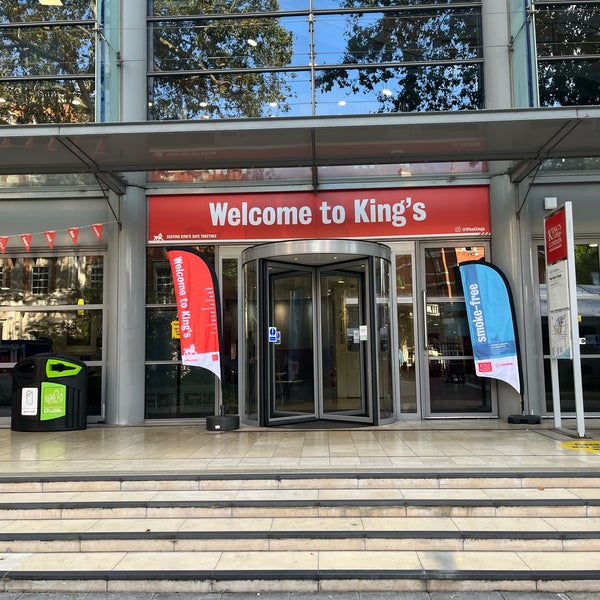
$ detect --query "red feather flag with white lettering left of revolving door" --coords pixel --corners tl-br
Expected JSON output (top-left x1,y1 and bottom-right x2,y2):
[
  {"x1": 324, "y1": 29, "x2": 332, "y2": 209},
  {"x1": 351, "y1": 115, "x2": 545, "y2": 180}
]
[{"x1": 167, "y1": 248, "x2": 221, "y2": 379}]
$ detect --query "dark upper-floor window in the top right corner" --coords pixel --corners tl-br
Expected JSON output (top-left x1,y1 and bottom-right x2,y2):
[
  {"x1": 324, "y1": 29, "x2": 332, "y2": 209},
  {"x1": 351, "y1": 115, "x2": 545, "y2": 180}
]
[{"x1": 534, "y1": 0, "x2": 600, "y2": 106}]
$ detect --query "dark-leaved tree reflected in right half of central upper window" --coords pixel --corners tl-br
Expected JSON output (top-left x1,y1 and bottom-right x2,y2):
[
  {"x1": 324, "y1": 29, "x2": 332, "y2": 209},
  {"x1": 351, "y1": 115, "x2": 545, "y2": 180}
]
[{"x1": 316, "y1": 0, "x2": 482, "y2": 112}]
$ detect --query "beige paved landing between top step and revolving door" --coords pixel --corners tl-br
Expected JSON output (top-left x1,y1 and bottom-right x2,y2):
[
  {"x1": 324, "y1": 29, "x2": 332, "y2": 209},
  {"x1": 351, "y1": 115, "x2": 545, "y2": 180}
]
[{"x1": 0, "y1": 420, "x2": 600, "y2": 476}]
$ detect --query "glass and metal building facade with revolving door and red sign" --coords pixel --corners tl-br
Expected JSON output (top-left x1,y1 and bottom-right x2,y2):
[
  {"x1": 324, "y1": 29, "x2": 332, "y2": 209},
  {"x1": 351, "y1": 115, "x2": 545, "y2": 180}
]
[{"x1": 0, "y1": 0, "x2": 600, "y2": 426}]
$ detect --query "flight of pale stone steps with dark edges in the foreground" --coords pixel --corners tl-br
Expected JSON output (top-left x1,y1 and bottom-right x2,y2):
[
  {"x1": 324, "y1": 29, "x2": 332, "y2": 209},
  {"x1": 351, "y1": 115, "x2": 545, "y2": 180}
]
[{"x1": 0, "y1": 473, "x2": 600, "y2": 593}]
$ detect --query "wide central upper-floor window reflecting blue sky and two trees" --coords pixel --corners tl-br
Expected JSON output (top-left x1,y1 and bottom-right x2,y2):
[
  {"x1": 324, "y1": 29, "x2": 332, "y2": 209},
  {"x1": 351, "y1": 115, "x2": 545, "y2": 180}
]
[{"x1": 149, "y1": 0, "x2": 483, "y2": 120}]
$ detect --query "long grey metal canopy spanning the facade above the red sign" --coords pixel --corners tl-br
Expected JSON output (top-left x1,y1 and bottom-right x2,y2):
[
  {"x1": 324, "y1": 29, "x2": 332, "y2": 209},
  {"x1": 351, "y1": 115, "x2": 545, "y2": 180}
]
[{"x1": 0, "y1": 107, "x2": 600, "y2": 193}]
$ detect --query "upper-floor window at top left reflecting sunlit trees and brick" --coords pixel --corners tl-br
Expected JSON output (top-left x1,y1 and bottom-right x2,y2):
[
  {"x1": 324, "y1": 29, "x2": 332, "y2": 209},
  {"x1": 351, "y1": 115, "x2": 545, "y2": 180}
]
[{"x1": 0, "y1": 0, "x2": 96, "y2": 125}]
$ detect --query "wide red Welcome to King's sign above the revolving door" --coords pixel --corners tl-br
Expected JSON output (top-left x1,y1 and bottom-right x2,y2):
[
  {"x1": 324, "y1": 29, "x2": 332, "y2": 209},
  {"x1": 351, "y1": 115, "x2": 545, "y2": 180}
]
[{"x1": 148, "y1": 186, "x2": 491, "y2": 242}]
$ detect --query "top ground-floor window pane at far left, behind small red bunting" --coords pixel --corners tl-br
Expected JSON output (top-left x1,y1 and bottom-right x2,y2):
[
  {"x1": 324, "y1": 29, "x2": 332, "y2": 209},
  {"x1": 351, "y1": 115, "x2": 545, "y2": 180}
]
[{"x1": 0, "y1": 256, "x2": 104, "y2": 306}]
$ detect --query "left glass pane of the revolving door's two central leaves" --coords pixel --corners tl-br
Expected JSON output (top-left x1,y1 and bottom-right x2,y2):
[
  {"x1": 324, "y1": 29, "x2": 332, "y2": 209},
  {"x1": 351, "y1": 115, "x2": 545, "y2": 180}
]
[{"x1": 269, "y1": 272, "x2": 315, "y2": 418}]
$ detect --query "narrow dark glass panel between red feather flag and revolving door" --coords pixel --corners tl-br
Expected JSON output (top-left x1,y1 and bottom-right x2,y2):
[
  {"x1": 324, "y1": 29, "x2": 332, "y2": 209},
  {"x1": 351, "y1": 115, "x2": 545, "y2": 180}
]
[{"x1": 221, "y1": 258, "x2": 239, "y2": 415}]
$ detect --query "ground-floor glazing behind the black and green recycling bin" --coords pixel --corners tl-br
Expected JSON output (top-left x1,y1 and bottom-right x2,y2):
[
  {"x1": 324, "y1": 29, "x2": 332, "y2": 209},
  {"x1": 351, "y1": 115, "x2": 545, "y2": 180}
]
[{"x1": 0, "y1": 255, "x2": 104, "y2": 417}]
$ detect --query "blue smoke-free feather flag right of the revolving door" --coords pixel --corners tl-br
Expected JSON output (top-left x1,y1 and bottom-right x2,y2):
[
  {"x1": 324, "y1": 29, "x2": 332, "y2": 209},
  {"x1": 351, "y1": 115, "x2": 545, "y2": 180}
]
[{"x1": 459, "y1": 260, "x2": 521, "y2": 393}]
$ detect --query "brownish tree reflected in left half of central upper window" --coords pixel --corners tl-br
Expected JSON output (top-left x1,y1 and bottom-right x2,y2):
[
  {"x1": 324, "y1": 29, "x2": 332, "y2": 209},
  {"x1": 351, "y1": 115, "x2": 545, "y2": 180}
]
[{"x1": 151, "y1": 0, "x2": 293, "y2": 119}]
